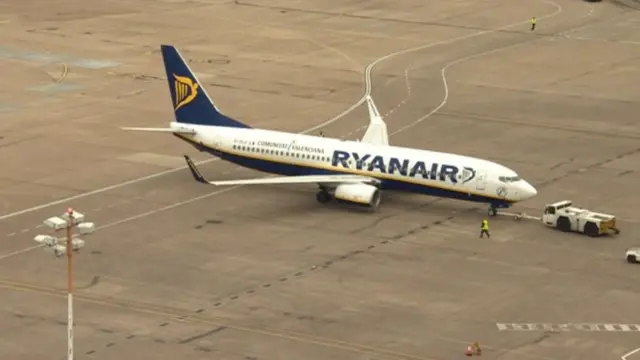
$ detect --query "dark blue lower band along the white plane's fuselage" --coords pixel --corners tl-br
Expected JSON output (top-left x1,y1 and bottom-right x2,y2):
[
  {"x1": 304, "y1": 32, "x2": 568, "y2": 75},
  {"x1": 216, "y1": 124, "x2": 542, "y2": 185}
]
[{"x1": 174, "y1": 134, "x2": 512, "y2": 208}]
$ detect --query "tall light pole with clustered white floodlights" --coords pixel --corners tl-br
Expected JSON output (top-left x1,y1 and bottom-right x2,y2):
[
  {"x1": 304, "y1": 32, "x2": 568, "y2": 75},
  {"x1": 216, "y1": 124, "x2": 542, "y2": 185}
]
[{"x1": 34, "y1": 208, "x2": 95, "y2": 360}]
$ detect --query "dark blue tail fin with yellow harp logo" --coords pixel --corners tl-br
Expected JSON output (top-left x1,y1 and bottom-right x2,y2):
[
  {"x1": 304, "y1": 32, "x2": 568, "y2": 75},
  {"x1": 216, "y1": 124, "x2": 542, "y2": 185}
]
[{"x1": 160, "y1": 45, "x2": 250, "y2": 128}]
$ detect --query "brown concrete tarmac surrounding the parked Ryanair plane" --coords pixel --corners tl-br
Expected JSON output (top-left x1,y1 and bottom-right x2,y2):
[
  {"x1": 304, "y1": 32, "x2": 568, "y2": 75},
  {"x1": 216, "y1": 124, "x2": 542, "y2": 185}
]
[{"x1": 0, "y1": 0, "x2": 640, "y2": 360}]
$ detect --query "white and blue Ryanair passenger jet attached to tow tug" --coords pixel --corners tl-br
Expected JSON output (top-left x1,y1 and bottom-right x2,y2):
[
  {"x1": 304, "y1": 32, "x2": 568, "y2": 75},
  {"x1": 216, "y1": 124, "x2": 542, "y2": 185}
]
[{"x1": 122, "y1": 45, "x2": 537, "y2": 216}]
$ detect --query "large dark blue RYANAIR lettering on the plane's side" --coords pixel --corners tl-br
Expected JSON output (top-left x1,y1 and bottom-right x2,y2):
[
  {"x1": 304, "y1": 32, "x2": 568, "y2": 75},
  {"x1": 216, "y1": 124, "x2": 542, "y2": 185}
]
[{"x1": 331, "y1": 150, "x2": 475, "y2": 184}]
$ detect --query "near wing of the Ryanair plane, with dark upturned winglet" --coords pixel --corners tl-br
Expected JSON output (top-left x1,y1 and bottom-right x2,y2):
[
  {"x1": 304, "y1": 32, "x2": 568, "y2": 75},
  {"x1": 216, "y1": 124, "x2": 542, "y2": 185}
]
[{"x1": 184, "y1": 155, "x2": 380, "y2": 186}]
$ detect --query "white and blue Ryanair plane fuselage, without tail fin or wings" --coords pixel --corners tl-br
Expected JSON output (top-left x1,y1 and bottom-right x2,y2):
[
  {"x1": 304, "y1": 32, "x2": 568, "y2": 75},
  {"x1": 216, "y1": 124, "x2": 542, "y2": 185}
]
[{"x1": 171, "y1": 122, "x2": 535, "y2": 208}]
